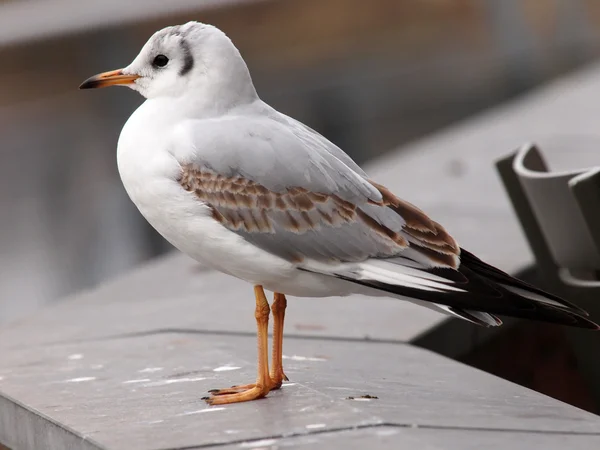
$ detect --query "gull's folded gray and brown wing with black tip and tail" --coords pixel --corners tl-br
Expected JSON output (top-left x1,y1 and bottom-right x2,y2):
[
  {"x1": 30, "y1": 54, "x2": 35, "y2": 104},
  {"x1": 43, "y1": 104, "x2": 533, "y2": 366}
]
[{"x1": 178, "y1": 112, "x2": 597, "y2": 329}]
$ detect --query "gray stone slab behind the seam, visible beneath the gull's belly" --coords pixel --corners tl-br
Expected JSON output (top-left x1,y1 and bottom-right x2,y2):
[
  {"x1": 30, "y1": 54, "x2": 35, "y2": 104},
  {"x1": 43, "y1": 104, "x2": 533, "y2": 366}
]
[{"x1": 0, "y1": 253, "x2": 445, "y2": 347}]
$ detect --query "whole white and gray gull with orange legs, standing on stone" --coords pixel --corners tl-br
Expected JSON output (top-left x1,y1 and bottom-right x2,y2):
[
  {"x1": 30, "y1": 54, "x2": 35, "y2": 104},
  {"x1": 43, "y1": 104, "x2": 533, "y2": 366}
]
[{"x1": 80, "y1": 22, "x2": 599, "y2": 405}]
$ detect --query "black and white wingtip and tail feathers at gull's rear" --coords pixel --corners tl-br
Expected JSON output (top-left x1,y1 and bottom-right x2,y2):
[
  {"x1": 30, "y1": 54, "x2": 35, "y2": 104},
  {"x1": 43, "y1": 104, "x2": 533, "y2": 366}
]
[{"x1": 303, "y1": 249, "x2": 600, "y2": 330}]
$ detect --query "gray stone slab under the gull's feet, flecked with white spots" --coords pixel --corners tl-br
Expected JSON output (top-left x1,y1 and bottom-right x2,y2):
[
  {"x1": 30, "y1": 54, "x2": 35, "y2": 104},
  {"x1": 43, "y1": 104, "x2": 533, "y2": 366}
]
[{"x1": 0, "y1": 333, "x2": 600, "y2": 449}]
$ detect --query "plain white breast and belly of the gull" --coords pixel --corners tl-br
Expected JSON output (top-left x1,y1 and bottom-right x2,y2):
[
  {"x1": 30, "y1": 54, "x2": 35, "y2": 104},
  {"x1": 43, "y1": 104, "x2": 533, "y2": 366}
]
[{"x1": 117, "y1": 101, "x2": 298, "y2": 285}]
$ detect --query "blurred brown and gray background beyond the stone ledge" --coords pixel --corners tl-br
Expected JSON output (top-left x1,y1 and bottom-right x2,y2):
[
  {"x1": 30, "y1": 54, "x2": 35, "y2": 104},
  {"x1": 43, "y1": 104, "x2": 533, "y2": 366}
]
[{"x1": 0, "y1": 0, "x2": 600, "y2": 323}]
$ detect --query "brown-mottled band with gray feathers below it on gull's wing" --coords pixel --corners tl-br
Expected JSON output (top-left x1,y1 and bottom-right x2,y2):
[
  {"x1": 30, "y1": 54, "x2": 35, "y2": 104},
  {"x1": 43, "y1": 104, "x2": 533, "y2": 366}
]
[{"x1": 179, "y1": 164, "x2": 408, "y2": 262}]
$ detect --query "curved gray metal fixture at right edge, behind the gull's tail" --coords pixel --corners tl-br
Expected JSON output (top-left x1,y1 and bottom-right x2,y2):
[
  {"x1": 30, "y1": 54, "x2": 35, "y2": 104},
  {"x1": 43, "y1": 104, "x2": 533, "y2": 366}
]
[{"x1": 496, "y1": 144, "x2": 600, "y2": 410}]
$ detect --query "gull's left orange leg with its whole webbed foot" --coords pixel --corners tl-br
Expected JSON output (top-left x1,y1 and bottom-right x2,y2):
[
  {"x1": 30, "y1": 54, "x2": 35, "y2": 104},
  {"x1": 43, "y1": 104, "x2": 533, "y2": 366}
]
[{"x1": 205, "y1": 286, "x2": 274, "y2": 405}]
